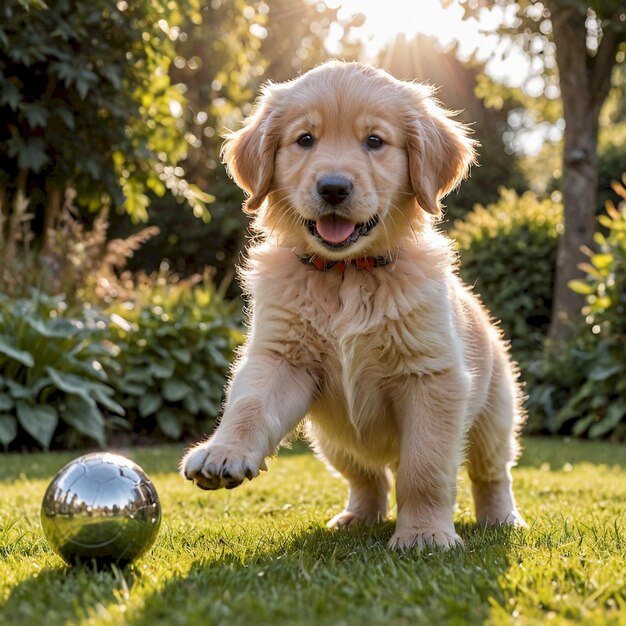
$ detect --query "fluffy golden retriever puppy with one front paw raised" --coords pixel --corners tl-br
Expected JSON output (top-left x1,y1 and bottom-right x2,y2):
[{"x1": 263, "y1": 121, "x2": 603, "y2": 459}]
[{"x1": 181, "y1": 61, "x2": 524, "y2": 548}]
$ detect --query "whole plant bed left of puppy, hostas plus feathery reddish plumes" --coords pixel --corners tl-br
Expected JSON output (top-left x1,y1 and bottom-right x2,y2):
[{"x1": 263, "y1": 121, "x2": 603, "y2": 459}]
[{"x1": 0, "y1": 188, "x2": 242, "y2": 449}]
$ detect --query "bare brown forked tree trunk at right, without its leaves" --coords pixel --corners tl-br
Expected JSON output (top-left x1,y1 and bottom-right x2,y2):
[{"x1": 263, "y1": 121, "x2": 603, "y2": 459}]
[{"x1": 550, "y1": 0, "x2": 617, "y2": 340}]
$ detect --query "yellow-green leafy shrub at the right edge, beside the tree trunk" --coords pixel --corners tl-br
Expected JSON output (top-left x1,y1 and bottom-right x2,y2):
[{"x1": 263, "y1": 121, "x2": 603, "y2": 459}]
[{"x1": 529, "y1": 176, "x2": 626, "y2": 440}]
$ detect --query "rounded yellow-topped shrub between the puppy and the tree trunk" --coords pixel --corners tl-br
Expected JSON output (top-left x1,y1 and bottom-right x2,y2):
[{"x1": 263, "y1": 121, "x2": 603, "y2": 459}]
[{"x1": 450, "y1": 188, "x2": 563, "y2": 361}]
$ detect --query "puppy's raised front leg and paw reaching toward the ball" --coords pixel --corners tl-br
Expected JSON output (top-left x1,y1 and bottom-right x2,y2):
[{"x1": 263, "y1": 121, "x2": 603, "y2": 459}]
[{"x1": 181, "y1": 354, "x2": 315, "y2": 489}]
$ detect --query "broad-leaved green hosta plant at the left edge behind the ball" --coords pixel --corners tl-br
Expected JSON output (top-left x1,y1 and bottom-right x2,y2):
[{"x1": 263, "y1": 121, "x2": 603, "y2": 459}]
[{"x1": 0, "y1": 291, "x2": 124, "y2": 449}]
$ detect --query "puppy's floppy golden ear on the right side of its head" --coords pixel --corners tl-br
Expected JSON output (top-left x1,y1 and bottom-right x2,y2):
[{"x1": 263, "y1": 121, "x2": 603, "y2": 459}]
[{"x1": 406, "y1": 84, "x2": 477, "y2": 215}]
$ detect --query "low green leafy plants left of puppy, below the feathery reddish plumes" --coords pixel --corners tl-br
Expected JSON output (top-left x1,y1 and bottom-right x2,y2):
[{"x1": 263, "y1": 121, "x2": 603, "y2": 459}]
[{"x1": 0, "y1": 276, "x2": 242, "y2": 449}]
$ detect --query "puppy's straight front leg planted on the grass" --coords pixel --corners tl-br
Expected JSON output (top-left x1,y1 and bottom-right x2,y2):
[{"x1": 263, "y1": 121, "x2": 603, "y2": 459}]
[{"x1": 389, "y1": 370, "x2": 467, "y2": 549}]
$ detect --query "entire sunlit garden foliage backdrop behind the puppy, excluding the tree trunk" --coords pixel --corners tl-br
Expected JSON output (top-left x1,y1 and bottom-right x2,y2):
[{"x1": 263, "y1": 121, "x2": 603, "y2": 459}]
[{"x1": 0, "y1": 0, "x2": 626, "y2": 449}]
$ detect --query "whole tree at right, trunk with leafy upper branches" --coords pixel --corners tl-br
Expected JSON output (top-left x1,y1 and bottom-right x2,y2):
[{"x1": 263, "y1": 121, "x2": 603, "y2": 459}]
[{"x1": 460, "y1": 0, "x2": 626, "y2": 339}]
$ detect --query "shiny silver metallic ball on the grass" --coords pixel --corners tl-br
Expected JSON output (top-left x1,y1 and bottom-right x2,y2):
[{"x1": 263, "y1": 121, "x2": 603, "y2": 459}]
[{"x1": 41, "y1": 452, "x2": 161, "y2": 563}]
